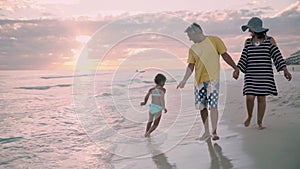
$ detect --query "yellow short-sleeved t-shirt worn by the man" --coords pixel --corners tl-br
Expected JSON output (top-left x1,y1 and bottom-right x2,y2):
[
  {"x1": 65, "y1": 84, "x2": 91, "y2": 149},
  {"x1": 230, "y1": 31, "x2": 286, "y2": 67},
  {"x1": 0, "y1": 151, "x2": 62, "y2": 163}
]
[{"x1": 187, "y1": 36, "x2": 227, "y2": 84}]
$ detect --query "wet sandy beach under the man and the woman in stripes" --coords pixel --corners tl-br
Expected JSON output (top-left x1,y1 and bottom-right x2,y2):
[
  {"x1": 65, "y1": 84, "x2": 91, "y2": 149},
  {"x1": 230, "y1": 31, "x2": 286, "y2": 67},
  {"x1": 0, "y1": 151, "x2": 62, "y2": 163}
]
[{"x1": 111, "y1": 66, "x2": 300, "y2": 169}]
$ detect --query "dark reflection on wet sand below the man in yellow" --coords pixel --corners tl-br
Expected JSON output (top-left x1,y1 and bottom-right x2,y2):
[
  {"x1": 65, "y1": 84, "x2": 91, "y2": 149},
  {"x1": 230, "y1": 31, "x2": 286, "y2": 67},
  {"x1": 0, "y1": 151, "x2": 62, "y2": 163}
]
[{"x1": 207, "y1": 139, "x2": 233, "y2": 169}]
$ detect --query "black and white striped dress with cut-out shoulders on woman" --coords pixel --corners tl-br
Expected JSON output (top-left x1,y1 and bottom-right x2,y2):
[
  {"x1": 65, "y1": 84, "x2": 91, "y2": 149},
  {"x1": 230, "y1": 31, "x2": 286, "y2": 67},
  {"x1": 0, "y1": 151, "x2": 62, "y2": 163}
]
[{"x1": 238, "y1": 37, "x2": 286, "y2": 96}]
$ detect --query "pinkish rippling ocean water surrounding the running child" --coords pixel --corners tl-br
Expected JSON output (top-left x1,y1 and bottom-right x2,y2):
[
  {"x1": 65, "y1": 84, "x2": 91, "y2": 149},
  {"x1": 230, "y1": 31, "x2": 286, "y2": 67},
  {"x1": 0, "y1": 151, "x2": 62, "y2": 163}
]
[{"x1": 0, "y1": 69, "x2": 244, "y2": 169}]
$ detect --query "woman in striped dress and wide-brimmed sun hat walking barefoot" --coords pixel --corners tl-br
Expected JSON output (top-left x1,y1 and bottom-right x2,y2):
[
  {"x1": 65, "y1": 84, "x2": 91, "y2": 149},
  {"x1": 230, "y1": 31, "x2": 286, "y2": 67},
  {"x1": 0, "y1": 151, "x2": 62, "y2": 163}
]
[{"x1": 238, "y1": 17, "x2": 292, "y2": 129}]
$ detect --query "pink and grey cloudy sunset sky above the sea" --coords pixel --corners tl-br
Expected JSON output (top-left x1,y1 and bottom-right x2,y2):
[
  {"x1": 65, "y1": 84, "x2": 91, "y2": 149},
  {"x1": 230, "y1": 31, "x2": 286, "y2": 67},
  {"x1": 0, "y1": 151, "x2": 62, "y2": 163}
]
[{"x1": 0, "y1": 0, "x2": 300, "y2": 70}]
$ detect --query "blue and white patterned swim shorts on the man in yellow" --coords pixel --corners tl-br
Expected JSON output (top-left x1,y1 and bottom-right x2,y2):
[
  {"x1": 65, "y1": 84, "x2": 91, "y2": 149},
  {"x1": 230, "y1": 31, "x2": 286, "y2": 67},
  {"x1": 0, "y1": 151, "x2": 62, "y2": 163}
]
[{"x1": 194, "y1": 80, "x2": 219, "y2": 110}]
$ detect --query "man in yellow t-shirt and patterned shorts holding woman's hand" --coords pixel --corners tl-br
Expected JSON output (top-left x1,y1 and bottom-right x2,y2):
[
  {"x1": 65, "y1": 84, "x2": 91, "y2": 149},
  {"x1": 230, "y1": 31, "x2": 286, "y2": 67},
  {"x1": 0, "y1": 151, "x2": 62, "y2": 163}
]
[{"x1": 177, "y1": 23, "x2": 239, "y2": 140}]
